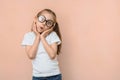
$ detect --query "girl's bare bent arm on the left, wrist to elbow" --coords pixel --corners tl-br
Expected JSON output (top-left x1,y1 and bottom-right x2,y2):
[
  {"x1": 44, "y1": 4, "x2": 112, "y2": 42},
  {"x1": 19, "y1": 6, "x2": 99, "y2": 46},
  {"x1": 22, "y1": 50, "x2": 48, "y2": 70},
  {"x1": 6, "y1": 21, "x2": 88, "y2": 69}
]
[{"x1": 25, "y1": 36, "x2": 40, "y2": 59}]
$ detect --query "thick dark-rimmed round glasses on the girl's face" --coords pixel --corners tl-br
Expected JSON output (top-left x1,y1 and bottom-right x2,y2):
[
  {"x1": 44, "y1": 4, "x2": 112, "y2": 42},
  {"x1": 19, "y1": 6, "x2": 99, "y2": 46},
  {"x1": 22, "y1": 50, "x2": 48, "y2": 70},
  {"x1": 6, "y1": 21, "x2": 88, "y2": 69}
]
[{"x1": 38, "y1": 15, "x2": 55, "y2": 27}]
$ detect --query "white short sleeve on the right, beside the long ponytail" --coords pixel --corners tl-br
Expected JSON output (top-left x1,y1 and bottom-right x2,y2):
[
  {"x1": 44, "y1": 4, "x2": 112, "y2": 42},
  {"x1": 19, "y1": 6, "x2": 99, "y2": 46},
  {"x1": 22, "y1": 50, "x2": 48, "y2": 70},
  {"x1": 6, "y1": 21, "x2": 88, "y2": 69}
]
[{"x1": 50, "y1": 32, "x2": 61, "y2": 45}]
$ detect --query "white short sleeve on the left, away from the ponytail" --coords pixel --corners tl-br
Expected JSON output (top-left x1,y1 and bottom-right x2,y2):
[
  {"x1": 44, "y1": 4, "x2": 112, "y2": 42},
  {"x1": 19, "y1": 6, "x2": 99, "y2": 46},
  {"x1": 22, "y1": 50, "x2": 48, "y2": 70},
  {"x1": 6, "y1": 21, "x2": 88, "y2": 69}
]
[{"x1": 21, "y1": 32, "x2": 35, "y2": 47}]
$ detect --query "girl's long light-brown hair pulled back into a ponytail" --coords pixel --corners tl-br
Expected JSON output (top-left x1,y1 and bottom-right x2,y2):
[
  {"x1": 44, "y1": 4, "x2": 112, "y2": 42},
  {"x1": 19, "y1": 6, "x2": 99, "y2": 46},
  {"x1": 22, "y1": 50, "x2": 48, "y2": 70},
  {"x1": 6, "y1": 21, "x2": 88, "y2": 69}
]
[{"x1": 31, "y1": 9, "x2": 62, "y2": 54}]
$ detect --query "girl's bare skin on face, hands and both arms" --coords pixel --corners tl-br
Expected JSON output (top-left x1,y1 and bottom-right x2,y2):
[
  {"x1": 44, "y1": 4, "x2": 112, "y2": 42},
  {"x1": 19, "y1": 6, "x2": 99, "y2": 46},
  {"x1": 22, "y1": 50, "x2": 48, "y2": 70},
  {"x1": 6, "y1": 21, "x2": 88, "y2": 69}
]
[{"x1": 25, "y1": 12, "x2": 57, "y2": 59}]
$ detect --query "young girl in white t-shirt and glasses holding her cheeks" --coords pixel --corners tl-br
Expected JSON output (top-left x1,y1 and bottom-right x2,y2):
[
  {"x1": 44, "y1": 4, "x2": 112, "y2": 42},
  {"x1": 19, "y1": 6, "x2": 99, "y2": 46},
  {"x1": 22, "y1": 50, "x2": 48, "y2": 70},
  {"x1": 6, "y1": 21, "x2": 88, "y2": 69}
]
[{"x1": 22, "y1": 9, "x2": 62, "y2": 80}]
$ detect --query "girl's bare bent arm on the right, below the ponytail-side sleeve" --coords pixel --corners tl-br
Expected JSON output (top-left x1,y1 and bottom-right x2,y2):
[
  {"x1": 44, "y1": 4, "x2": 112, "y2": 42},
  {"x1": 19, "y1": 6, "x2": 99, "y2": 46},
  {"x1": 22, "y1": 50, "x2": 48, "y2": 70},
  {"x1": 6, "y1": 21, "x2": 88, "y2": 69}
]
[{"x1": 41, "y1": 37, "x2": 57, "y2": 59}]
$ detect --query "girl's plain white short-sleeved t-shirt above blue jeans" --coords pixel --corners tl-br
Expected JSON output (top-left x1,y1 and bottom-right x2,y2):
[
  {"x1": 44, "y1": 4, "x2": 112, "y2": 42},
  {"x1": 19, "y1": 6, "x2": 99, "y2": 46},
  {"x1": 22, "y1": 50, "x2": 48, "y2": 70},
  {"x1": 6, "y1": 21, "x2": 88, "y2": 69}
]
[{"x1": 22, "y1": 31, "x2": 61, "y2": 77}]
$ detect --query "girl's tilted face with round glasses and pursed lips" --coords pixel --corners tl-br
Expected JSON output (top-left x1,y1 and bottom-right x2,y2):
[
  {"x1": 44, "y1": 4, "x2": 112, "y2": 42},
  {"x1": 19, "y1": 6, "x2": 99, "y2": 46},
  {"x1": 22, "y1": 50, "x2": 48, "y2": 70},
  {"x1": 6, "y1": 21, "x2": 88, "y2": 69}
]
[{"x1": 36, "y1": 11, "x2": 55, "y2": 33}]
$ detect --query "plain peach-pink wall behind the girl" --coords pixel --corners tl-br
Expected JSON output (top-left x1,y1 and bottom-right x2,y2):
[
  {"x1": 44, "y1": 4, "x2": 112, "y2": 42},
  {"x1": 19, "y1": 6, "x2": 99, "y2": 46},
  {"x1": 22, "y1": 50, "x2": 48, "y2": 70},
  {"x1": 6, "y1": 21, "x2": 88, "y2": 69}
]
[{"x1": 0, "y1": 0, "x2": 120, "y2": 80}]
